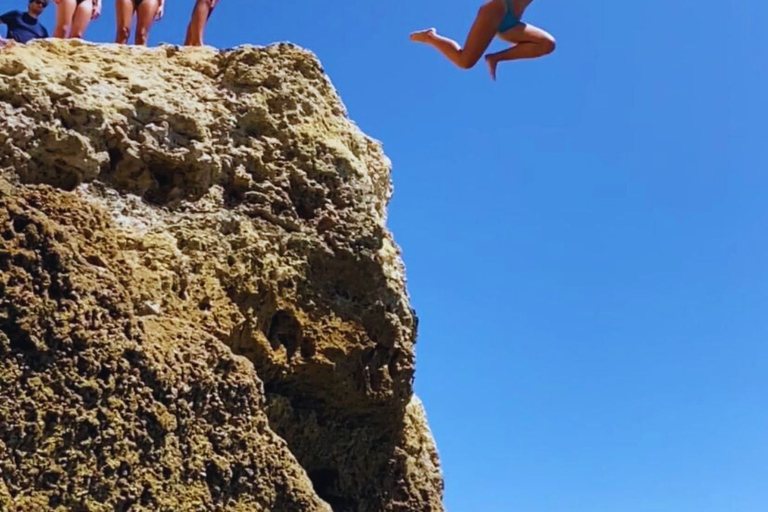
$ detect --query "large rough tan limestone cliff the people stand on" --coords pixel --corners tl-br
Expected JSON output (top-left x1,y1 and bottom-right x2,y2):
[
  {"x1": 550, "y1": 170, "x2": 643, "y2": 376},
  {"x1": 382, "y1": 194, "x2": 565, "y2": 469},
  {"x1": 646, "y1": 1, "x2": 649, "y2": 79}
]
[{"x1": 0, "y1": 41, "x2": 443, "y2": 512}]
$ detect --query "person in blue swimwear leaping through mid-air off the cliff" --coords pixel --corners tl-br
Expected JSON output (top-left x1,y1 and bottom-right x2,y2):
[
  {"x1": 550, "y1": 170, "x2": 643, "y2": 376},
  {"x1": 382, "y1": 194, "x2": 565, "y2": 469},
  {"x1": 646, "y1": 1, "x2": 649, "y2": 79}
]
[{"x1": 411, "y1": 0, "x2": 555, "y2": 80}]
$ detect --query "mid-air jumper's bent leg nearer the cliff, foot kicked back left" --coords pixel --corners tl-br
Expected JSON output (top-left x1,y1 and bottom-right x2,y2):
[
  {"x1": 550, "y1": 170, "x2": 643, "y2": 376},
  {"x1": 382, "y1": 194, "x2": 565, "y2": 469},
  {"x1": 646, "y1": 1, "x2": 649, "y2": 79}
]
[{"x1": 411, "y1": 0, "x2": 504, "y2": 69}]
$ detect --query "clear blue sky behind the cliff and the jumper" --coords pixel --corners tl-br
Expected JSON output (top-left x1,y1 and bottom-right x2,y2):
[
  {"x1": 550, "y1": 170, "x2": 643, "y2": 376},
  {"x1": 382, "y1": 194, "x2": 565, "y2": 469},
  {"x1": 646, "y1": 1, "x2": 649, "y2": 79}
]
[{"x1": 16, "y1": 0, "x2": 768, "y2": 512}]
